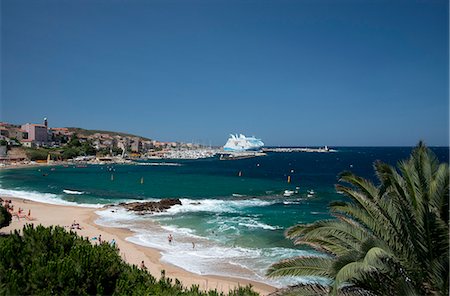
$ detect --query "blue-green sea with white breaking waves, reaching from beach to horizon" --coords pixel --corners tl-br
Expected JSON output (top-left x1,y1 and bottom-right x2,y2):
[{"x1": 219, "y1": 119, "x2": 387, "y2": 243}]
[{"x1": 0, "y1": 147, "x2": 449, "y2": 287}]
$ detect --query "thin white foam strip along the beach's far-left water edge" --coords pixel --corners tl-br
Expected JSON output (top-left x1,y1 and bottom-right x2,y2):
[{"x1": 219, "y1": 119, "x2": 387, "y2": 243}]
[{"x1": 0, "y1": 188, "x2": 104, "y2": 208}]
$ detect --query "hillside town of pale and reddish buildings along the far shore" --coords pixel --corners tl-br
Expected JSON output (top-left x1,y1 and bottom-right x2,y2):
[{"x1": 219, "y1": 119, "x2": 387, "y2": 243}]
[{"x1": 0, "y1": 118, "x2": 215, "y2": 163}]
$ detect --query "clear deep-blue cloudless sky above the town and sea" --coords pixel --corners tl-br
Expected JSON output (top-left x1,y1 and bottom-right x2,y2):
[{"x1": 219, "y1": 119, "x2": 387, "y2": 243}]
[{"x1": 0, "y1": 0, "x2": 449, "y2": 146}]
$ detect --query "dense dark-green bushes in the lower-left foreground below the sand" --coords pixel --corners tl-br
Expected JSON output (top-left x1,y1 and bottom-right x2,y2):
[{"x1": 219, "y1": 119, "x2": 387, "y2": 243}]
[{"x1": 0, "y1": 225, "x2": 258, "y2": 296}]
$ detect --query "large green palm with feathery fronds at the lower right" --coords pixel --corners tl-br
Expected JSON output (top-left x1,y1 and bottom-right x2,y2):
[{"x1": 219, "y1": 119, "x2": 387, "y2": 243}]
[{"x1": 267, "y1": 142, "x2": 449, "y2": 295}]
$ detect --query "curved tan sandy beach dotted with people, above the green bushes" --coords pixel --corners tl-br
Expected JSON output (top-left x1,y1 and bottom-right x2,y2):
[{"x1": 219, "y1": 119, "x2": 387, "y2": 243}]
[{"x1": 0, "y1": 197, "x2": 276, "y2": 295}]
